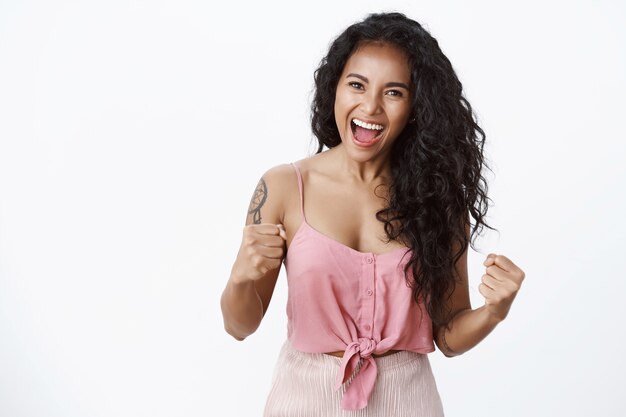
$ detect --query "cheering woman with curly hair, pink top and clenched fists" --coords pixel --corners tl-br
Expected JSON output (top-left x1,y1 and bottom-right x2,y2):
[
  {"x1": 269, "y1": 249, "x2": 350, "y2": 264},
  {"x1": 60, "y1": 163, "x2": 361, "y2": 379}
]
[{"x1": 221, "y1": 13, "x2": 524, "y2": 417}]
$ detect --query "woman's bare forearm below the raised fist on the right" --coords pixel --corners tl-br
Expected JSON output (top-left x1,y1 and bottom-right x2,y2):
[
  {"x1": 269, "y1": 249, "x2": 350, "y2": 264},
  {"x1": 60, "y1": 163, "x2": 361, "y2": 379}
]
[{"x1": 435, "y1": 306, "x2": 501, "y2": 357}]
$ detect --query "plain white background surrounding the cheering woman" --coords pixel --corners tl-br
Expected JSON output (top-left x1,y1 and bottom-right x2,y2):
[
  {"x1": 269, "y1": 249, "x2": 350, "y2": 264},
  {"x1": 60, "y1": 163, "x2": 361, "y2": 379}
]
[{"x1": 0, "y1": 0, "x2": 626, "y2": 417}]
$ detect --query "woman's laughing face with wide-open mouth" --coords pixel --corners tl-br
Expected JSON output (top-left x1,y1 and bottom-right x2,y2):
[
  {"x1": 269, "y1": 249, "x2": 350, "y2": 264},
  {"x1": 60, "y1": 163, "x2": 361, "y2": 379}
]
[{"x1": 335, "y1": 43, "x2": 411, "y2": 157}]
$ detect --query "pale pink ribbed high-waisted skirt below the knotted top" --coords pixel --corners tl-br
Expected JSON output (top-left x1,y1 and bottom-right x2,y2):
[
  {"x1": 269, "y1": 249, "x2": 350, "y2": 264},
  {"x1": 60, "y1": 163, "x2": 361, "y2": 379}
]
[{"x1": 263, "y1": 340, "x2": 444, "y2": 417}]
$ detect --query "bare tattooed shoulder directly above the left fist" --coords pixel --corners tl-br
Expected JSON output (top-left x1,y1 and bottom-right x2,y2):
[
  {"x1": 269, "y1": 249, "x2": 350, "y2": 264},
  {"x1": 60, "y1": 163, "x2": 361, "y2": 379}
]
[{"x1": 246, "y1": 164, "x2": 294, "y2": 224}]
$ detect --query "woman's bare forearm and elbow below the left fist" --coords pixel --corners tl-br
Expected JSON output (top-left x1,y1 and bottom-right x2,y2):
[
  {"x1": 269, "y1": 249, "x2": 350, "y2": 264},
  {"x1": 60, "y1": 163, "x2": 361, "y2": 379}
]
[{"x1": 220, "y1": 275, "x2": 263, "y2": 341}]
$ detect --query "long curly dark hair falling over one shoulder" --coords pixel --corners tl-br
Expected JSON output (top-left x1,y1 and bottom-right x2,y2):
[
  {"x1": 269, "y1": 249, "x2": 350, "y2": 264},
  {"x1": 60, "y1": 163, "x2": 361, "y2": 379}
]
[{"x1": 311, "y1": 13, "x2": 497, "y2": 325}]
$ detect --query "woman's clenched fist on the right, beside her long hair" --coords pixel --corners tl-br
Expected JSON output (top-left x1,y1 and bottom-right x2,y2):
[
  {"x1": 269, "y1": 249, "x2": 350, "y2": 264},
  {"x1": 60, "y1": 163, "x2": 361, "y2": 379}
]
[{"x1": 478, "y1": 253, "x2": 525, "y2": 321}]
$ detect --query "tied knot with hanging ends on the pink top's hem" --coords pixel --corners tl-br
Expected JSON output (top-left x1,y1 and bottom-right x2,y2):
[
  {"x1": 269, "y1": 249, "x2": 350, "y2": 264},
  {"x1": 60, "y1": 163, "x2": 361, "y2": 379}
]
[{"x1": 335, "y1": 337, "x2": 378, "y2": 410}]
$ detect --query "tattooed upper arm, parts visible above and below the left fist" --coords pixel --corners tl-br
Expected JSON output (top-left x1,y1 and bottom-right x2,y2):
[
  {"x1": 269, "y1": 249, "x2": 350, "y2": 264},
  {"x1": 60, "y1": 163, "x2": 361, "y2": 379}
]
[{"x1": 246, "y1": 165, "x2": 288, "y2": 315}]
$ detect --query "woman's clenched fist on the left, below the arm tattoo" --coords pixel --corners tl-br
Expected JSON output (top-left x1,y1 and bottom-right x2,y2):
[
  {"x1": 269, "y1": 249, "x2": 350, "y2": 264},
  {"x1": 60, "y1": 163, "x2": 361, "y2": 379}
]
[{"x1": 233, "y1": 223, "x2": 287, "y2": 281}]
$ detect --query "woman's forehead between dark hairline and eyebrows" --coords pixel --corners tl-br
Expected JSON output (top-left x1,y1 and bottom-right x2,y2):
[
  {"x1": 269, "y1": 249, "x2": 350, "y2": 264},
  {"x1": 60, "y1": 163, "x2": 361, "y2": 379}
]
[{"x1": 342, "y1": 42, "x2": 411, "y2": 83}]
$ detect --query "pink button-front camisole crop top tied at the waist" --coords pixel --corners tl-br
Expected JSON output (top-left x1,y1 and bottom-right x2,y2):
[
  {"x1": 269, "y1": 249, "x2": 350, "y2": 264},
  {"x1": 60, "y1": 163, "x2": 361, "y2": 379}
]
[{"x1": 284, "y1": 163, "x2": 435, "y2": 410}]
